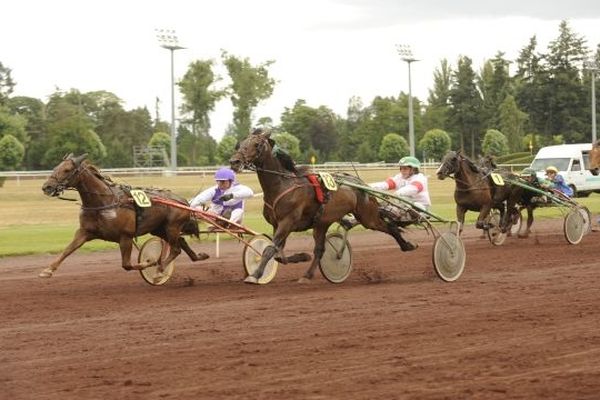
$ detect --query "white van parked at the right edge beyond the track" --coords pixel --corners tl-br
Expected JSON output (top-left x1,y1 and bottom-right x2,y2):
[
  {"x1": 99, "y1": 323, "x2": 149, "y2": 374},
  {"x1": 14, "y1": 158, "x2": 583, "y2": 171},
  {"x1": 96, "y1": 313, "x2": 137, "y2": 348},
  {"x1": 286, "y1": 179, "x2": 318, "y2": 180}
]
[{"x1": 531, "y1": 143, "x2": 600, "y2": 197}]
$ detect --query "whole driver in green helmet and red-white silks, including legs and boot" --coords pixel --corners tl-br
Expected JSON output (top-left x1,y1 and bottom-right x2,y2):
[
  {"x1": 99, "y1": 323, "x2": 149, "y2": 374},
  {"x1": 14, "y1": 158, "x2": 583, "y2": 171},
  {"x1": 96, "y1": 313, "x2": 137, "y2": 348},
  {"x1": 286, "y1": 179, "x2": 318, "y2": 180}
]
[{"x1": 341, "y1": 156, "x2": 431, "y2": 229}]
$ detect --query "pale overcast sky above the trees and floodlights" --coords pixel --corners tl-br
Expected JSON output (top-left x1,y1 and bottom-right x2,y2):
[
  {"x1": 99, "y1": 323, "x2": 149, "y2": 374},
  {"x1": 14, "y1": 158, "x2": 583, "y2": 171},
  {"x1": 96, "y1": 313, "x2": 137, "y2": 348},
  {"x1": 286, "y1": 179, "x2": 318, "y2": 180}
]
[{"x1": 0, "y1": 0, "x2": 600, "y2": 140}]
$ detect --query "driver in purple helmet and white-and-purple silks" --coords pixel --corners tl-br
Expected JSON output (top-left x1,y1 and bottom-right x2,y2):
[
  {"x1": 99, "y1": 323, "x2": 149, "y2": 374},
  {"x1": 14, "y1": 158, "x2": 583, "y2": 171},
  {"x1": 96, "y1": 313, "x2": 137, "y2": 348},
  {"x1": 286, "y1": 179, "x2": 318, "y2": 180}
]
[{"x1": 190, "y1": 168, "x2": 254, "y2": 224}]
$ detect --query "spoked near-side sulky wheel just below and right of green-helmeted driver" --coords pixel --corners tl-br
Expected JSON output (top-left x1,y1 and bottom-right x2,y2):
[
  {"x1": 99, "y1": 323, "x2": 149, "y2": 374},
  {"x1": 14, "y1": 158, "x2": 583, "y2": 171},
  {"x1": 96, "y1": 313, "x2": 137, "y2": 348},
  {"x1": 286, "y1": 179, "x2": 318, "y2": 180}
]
[{"x1": 433, "y1": 232, "x2": 467, "y2": 282}]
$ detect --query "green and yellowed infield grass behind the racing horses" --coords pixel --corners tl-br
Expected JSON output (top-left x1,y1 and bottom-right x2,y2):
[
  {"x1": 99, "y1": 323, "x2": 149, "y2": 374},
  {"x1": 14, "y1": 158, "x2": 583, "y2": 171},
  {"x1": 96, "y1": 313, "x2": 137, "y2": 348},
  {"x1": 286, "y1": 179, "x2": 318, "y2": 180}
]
[{"x1": 0, "y1": 169, "x2": 600, "y2": 257}]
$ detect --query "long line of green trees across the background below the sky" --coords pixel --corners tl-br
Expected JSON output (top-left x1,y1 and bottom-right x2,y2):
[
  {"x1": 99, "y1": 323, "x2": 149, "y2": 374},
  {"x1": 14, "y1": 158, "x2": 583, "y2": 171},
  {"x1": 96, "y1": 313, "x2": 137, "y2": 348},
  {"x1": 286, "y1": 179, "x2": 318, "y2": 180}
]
[{"x1": 0, "y1": 21, "x2": 600, "y2": 170}]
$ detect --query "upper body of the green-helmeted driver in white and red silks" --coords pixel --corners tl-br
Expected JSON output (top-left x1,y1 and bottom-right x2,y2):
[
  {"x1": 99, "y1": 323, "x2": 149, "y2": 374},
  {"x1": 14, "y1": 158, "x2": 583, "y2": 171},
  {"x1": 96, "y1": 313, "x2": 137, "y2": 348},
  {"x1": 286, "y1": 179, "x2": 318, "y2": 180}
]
[{"x1": 369, "y1": 156, "x2": 431, "y2": 210}]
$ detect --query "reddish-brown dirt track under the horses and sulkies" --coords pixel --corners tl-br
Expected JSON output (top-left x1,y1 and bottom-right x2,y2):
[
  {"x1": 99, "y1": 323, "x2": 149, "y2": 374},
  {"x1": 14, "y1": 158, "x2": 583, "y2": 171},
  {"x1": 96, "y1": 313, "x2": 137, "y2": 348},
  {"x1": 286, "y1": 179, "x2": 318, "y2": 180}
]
[{"x1": 0, "y1": 220, "x2": 600, "y2": 399}]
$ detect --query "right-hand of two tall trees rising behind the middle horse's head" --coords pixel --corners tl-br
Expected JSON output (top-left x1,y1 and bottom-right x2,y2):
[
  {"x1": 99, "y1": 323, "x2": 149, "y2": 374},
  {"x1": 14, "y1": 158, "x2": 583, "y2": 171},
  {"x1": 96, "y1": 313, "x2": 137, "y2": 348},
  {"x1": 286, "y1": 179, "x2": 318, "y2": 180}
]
[{"x1": 221, "y1": 50, "x2": 276, "y2": 139}]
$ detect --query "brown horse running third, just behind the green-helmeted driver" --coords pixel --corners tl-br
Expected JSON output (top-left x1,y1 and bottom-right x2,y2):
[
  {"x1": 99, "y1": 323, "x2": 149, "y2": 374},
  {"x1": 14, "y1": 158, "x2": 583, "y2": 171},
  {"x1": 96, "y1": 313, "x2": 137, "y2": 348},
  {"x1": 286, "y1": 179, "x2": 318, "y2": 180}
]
[{"x1": 436, "y1": 150, "x2": 521, "y2": 232}]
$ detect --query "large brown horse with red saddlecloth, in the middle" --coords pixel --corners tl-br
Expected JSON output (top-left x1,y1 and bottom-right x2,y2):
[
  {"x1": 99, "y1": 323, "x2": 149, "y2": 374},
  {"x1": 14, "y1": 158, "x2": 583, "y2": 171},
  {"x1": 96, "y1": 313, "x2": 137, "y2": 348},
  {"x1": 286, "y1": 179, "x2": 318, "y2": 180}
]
[{"x1": 229, "y1": 129, "x2": 416, "y2": 283}]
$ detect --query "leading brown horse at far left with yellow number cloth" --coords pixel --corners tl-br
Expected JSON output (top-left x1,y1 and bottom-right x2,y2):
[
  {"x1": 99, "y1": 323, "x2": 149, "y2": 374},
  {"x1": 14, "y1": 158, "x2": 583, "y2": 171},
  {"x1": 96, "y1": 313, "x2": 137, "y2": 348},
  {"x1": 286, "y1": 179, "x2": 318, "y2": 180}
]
[{"x1": 39, "y1": 154, "x2": 206, "y2": 278}]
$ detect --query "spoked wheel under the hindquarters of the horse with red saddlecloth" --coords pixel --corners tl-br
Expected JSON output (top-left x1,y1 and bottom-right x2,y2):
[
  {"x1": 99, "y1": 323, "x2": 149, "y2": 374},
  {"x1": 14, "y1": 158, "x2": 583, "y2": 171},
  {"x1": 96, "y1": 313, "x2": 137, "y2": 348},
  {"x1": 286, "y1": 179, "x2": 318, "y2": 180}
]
[{"x1": 319, "y1": 233, "x2": 352, "y2": 283}]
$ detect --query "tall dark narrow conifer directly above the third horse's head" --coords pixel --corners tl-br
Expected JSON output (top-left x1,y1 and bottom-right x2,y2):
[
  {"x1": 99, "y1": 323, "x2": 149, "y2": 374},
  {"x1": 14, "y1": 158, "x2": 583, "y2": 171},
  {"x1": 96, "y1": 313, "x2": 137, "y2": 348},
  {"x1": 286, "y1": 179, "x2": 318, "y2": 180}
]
[{"x1": 449, "y1": 56, "x2": 482, "y2": 157}]
